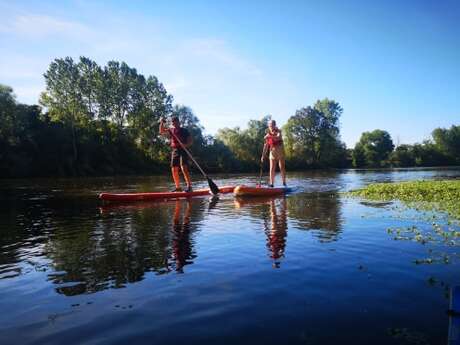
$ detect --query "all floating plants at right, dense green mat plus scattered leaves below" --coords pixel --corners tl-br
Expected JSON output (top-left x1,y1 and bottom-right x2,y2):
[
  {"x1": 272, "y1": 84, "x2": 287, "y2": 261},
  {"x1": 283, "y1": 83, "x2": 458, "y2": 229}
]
[{"x1": 348, "y1": 180, "x2": 460, "y2": 265}]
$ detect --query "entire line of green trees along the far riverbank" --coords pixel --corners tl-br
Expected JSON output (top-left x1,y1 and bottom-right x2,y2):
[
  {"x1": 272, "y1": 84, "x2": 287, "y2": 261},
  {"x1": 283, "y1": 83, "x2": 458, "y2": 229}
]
[{"x1": 0, "y1": 57, "x2": 460, "y2": 177}]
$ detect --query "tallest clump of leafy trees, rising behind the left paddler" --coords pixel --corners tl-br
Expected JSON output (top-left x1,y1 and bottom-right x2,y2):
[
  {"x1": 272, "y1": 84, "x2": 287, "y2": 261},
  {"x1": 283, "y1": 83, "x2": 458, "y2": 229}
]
[{"x1": 40, "y1": 57, "x2": 172, "y2": 173}]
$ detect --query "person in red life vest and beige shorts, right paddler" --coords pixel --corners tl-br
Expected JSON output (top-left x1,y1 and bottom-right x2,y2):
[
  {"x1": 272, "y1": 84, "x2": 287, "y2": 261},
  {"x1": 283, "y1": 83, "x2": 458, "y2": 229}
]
[{"x1": 260, "y1": 120, "x2": 286, "y2": 187}]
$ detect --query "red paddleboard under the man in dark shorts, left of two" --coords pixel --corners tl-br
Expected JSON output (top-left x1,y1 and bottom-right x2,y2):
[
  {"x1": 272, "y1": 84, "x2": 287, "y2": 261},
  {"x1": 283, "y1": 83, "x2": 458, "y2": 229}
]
[{"x1": 99, "y1": 186, "x2": 235, "y2": 202}]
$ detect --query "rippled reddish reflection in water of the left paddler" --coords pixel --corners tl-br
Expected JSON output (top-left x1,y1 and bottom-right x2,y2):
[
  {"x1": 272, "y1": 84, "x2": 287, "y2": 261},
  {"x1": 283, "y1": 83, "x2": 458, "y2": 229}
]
[{"x1": 172, "y1": 200, "x2": 195, "y2": 273}]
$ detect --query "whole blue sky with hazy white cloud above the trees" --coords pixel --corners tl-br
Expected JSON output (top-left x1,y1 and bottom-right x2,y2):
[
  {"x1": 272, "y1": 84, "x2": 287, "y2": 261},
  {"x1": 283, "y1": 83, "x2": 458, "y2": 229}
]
[{"x1": 0, "y1": 0, "x2": 460, "y2": 147}]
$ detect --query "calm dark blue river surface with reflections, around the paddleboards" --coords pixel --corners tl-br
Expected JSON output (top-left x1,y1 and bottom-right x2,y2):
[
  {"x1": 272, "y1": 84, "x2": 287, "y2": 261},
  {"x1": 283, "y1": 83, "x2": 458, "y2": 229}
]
[{"x1": 0, "y1": 169, "x2": 460, "y2": 344}]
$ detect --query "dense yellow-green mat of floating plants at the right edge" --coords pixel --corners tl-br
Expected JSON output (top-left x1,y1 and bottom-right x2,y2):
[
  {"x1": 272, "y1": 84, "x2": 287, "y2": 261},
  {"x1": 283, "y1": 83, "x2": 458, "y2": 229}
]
[{"x1": 348, "y1": 180, "x2": 460, "y2": 220}]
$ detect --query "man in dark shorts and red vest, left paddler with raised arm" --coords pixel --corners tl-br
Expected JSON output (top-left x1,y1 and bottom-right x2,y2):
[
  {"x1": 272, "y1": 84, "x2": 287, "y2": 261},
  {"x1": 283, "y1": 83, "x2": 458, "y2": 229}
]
[{"x1": 160, "y1": 117, "x2": 192, "y2": 192}]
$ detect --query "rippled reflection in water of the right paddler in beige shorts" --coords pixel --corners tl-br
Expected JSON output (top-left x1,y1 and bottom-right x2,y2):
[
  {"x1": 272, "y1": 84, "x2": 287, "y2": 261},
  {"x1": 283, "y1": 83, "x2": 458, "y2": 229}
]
[{"x1": 265, "y1": 198, "x2": 287, "y2": 268}]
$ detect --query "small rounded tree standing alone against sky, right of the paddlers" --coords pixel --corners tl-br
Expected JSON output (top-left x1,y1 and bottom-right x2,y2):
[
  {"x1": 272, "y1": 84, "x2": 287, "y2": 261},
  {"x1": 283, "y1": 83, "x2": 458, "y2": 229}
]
[{"x1": 353, "y1": 129, "x2": 394, "y2": 168}]
